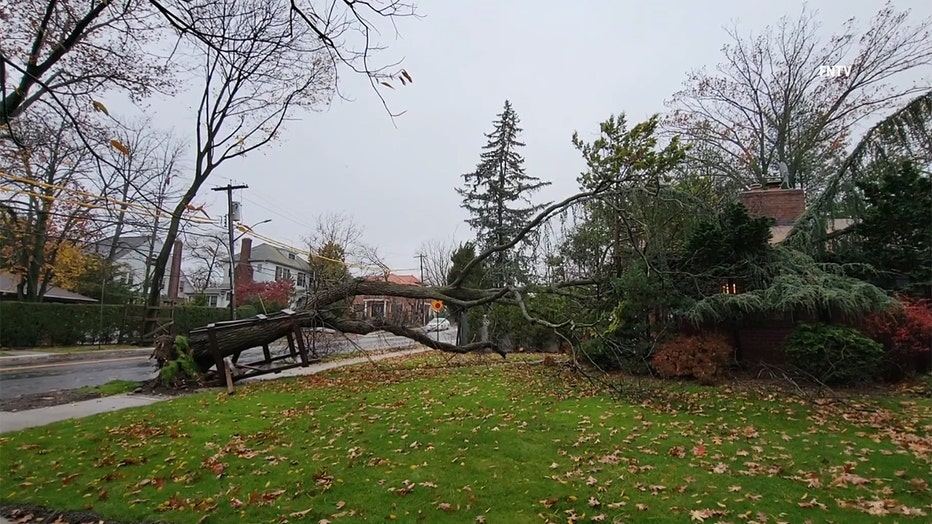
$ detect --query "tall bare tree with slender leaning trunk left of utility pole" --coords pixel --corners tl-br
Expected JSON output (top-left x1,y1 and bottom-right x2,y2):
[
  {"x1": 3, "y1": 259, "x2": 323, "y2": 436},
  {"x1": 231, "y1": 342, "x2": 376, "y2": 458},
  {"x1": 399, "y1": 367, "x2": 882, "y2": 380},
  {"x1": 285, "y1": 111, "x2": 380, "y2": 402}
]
[{"x1": 147, "y1": 0, "x2": 410, "y2": 331}]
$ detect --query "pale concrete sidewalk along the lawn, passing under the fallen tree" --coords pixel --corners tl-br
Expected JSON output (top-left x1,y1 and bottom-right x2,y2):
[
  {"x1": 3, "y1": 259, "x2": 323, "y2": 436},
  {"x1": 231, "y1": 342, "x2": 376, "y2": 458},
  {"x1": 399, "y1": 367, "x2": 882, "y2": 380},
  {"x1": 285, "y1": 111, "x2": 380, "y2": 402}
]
[{"x1": 0, "y1": 346, "x2": 432, "y2": 434}]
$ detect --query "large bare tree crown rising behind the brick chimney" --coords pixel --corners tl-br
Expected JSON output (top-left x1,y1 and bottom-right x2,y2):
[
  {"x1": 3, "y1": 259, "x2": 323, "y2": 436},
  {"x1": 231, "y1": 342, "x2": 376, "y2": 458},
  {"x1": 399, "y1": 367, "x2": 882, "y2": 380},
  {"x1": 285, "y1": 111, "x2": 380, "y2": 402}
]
[{"x1": 666, "y1": 3, "x2": 932, "y2": 193}]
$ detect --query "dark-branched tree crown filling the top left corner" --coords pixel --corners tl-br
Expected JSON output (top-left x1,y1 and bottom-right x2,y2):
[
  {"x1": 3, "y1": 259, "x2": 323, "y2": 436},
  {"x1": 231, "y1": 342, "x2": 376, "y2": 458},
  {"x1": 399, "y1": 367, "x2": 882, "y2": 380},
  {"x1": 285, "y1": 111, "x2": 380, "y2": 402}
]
[{"x1": 0, "y1": 0, "x2": 176, "y2": 124}]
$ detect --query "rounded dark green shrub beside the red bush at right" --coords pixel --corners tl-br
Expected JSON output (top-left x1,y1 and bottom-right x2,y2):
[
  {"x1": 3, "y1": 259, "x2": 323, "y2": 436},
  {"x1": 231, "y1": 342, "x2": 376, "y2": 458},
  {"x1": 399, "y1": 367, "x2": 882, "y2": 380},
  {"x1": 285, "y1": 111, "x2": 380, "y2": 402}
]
[{"x1": 785, "y1": 324, "x2": 884, "y2": 385}]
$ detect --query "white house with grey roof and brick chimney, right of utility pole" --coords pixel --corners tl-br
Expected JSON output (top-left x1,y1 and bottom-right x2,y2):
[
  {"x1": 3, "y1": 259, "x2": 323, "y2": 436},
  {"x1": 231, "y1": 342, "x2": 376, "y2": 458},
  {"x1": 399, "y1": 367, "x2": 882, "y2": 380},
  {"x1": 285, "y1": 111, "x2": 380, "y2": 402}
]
[{"x1": 204, "y1": 238, "x2": 311, "y2": 307}]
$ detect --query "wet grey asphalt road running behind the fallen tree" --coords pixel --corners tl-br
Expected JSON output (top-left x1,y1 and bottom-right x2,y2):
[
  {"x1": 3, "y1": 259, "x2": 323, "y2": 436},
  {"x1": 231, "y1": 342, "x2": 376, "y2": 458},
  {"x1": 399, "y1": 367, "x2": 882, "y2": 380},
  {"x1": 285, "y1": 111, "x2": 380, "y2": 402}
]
[{"x1": 0, "y1": 329, "x2": 456, "y2": 399}]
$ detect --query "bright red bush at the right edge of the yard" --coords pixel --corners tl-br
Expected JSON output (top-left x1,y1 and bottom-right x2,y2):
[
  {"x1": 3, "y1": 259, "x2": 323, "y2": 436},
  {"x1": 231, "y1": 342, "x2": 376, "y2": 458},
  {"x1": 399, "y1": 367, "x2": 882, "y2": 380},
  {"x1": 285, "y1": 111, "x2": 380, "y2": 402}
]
[{"x1": 864, "y1": 297, "x2": 932, "y2": 380}]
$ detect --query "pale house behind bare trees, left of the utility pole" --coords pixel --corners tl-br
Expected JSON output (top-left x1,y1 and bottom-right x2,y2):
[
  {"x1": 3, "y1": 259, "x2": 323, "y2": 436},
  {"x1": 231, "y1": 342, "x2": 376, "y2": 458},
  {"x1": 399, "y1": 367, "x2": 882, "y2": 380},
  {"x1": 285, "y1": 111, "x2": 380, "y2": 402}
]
[{"x1": 90, "y1": 235, "x2": 195, "y2": 301}]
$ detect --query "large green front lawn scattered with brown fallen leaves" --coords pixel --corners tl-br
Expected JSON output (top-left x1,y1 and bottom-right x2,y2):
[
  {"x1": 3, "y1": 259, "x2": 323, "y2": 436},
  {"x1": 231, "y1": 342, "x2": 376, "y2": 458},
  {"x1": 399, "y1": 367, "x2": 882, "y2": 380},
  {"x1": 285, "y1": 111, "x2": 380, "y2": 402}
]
[{"x1": 0, "y1": 354, "x2": 932, "y2": 523}]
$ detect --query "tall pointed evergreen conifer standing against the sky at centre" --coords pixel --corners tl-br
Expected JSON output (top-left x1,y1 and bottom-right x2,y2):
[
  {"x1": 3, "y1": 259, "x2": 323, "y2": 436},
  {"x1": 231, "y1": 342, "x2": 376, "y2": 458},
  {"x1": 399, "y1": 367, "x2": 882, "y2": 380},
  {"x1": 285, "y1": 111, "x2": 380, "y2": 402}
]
[{"x1": 456, "y1": 100, "x2": 550, "y2": 286}]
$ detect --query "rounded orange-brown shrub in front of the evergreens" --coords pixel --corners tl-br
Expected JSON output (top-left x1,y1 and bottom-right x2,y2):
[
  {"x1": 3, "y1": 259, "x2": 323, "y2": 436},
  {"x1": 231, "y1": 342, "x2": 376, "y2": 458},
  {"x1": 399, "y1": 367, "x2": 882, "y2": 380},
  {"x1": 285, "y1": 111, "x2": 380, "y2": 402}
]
[{"x1": 651, "y1": 333, "x2": 734, "y2": 384}]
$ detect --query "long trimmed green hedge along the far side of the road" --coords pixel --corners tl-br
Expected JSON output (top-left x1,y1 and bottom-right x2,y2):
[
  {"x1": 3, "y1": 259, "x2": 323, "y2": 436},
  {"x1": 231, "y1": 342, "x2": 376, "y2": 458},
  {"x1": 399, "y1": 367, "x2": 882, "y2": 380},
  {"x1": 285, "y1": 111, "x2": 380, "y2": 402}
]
[{"x1": 0, "y1": 302, "x2": 256, "y2": 347}]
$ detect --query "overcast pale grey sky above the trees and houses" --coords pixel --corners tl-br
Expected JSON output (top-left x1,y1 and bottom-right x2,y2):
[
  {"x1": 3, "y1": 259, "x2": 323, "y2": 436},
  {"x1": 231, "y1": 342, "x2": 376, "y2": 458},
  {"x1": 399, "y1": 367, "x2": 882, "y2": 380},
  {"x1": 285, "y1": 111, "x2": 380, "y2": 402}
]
[{"x1": 158, "y1": 0, "x2": 932, "y2": 274}]
